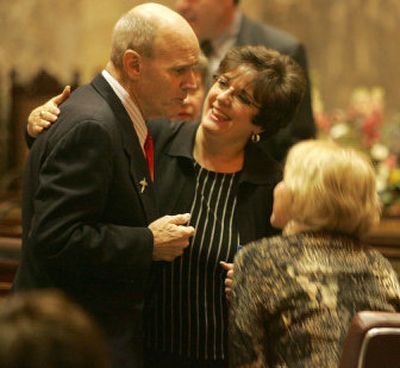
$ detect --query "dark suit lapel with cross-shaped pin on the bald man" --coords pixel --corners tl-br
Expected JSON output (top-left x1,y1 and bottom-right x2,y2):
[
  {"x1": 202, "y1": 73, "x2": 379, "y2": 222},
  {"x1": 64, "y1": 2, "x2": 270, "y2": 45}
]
[{"x1": 92, "y1": 74, "x2": 158, "y2": 223}]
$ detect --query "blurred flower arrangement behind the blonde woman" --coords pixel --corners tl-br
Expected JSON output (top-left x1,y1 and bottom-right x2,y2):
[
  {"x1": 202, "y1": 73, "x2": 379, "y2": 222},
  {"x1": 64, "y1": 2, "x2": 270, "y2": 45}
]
[{"x1": 314, "y1": 87, "x2": 400, "y2": 216}]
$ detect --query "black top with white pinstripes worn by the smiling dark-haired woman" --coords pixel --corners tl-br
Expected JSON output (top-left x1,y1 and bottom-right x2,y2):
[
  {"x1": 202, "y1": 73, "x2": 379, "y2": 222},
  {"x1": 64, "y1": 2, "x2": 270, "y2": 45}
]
[{"x1": 149, "y1": 165, "x2": 239, "y2": 359}]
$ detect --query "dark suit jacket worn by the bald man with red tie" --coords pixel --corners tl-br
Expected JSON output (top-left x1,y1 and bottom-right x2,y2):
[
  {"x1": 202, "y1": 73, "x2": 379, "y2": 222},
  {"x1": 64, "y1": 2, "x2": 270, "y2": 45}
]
[{"x1": 14, "y1": 75, "x2": 158, "y2": 367}]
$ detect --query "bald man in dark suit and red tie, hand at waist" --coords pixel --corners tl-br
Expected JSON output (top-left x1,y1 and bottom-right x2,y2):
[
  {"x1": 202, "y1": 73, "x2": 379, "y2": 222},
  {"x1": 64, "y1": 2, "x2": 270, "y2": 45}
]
[{"x1": 14, "y1": 3, "x2": 200, "y2": 368}]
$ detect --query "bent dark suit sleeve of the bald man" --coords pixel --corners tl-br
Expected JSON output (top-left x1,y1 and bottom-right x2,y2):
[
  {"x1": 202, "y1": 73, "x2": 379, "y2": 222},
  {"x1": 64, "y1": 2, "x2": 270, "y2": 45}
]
[{"x1": 29, "y1": 122, "x2": 153, "y2": 280}]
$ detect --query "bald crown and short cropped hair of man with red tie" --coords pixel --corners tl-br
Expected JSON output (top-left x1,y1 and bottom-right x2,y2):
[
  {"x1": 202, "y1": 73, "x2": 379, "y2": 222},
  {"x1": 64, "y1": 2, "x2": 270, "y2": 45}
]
[{"x1": 111, "y1": 3, "x2": 197, "y2": 69}]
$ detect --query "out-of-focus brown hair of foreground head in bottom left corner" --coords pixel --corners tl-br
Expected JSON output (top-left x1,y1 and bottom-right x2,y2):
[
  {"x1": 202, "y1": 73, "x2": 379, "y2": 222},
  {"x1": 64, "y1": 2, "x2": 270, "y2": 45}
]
[{"x1": 0, "y1": 290, "x2": 110, "y2": 368}]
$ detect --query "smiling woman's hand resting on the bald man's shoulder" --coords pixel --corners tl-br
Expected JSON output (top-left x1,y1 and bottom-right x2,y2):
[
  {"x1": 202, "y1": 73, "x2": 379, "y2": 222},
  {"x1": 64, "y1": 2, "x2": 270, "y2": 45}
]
[{"x1": 26, "y1": 86, "x2": 71, "y2": 138}]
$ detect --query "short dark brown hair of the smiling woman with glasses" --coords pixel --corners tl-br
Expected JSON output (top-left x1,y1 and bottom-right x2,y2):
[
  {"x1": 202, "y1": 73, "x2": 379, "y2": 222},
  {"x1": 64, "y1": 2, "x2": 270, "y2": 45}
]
[{"x1": 217, "y1": 46, "x2": 306, "y2": 136}]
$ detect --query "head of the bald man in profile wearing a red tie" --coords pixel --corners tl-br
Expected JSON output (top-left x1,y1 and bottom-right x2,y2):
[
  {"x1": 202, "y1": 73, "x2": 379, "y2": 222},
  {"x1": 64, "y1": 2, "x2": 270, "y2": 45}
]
[{"x1": 107, "y1": 3, "x2": 200, "y2": 119}]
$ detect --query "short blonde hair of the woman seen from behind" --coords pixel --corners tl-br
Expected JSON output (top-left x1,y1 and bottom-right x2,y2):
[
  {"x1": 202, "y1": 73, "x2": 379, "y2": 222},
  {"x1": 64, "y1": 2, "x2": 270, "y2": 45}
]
[{"x1": 284, "y1": 140, "x2": 381, "y2": 237}]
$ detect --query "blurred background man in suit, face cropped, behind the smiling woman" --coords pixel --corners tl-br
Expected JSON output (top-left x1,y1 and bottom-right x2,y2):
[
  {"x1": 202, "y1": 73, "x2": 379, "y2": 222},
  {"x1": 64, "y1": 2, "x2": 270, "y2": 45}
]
[{"x1": 175, "y1": 0, "x2": 316, "y2": 161}]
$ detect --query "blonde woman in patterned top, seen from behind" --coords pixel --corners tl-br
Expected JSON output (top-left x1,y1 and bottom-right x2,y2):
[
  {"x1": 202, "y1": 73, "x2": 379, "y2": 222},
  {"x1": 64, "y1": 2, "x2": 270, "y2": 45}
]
[{"x1": 229, "y1": 141, "x2": 400, "y2": 367}]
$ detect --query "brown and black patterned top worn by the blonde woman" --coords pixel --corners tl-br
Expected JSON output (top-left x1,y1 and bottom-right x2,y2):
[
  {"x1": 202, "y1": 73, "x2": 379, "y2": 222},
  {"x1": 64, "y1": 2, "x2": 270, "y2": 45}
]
[{"x1": 229, "y1": 233, "x2": 400, "y2": 368}]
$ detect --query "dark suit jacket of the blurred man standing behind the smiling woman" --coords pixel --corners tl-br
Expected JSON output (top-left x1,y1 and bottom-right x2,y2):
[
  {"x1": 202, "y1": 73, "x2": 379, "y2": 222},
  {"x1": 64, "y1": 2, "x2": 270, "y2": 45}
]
[{"x1": 235, "y1": 15, "x2": 316, "y2": 161}]
